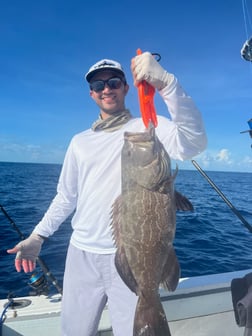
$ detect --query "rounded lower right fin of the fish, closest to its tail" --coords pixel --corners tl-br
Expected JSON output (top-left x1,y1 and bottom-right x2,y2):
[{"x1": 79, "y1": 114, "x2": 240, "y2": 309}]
[{"x1": 161, "y1": 247, "x2": 180, "y2": 292}]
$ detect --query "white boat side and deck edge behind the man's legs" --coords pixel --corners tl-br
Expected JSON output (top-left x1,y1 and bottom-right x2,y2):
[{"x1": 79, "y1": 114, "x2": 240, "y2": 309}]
[{"x1": 0, "y1": 269, "x2": 252, "y2": 336}]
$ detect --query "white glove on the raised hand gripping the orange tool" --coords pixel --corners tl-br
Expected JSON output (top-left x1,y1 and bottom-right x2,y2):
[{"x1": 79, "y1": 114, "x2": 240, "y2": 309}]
[{"x1": 134, "y1": 52, "x2": 174, "y2": 90}]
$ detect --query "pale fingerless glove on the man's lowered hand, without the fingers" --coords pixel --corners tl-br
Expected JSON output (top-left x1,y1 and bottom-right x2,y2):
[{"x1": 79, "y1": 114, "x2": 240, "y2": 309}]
[{"x1": 15, "y1": 233, "x2": 44, "y2": 262}]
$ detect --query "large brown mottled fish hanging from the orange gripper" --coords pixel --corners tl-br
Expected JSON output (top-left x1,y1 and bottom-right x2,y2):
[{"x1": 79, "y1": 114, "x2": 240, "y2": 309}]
[{"x1": 112, "y1": 125, "x2": 192, "y2": 336}]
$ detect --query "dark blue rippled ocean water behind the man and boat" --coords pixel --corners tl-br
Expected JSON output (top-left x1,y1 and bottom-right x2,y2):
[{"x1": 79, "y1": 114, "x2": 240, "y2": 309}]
[{"x1": 0, "y1": 162, "x2": 252, "y2": 299}]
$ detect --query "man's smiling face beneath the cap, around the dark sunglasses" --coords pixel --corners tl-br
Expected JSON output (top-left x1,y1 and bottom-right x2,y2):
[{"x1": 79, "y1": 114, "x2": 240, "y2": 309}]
[{"x1": 90, "y1": 71, "x2": 129, "y2": 119}]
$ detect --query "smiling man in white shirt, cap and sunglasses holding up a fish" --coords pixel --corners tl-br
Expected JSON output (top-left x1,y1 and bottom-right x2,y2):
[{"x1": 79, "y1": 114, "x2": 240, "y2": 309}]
[{"x1": 8, "y1": 52, "x2": 206, "y2": 336}]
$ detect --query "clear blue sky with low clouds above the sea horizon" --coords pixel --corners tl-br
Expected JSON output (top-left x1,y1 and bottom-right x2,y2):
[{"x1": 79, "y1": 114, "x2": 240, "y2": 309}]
[{"x1": 0, "y1": 0, "x2": 252, "y2": 172}]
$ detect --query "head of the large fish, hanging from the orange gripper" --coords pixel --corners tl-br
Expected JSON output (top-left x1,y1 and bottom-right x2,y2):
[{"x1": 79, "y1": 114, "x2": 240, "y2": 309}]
[{"x1": 122, "y1": 127, "x2": 171, "y2": 190}]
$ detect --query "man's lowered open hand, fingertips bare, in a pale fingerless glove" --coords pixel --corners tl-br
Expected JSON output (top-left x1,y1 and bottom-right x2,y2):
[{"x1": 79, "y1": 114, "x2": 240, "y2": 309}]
[{"x1": 7, "y1": 233, "x2": 44, "y2": 272}]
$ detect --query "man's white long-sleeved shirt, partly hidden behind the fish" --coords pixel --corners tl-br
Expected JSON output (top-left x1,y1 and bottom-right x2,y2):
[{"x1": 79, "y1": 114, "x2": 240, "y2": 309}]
[{"x1": 34, "y1": 78, "x2": 207, "y2": 254}]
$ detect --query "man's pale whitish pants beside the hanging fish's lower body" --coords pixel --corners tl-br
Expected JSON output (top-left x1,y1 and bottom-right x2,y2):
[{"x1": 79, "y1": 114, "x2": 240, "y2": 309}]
[{"x1": 61, "y1": 244, "x2": 137, "y2": 336}]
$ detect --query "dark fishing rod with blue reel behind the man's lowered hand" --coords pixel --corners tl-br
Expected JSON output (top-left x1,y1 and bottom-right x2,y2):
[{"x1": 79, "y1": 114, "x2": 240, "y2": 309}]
[{"x1": 0, "y1": 204, "x2": 62, "y2": 294}]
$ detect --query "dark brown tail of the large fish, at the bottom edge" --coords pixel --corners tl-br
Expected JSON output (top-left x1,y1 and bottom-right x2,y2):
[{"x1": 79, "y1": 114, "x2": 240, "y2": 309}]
[{"x1": 133, "y1": 295, "x2": 171, "y2": 336}]
